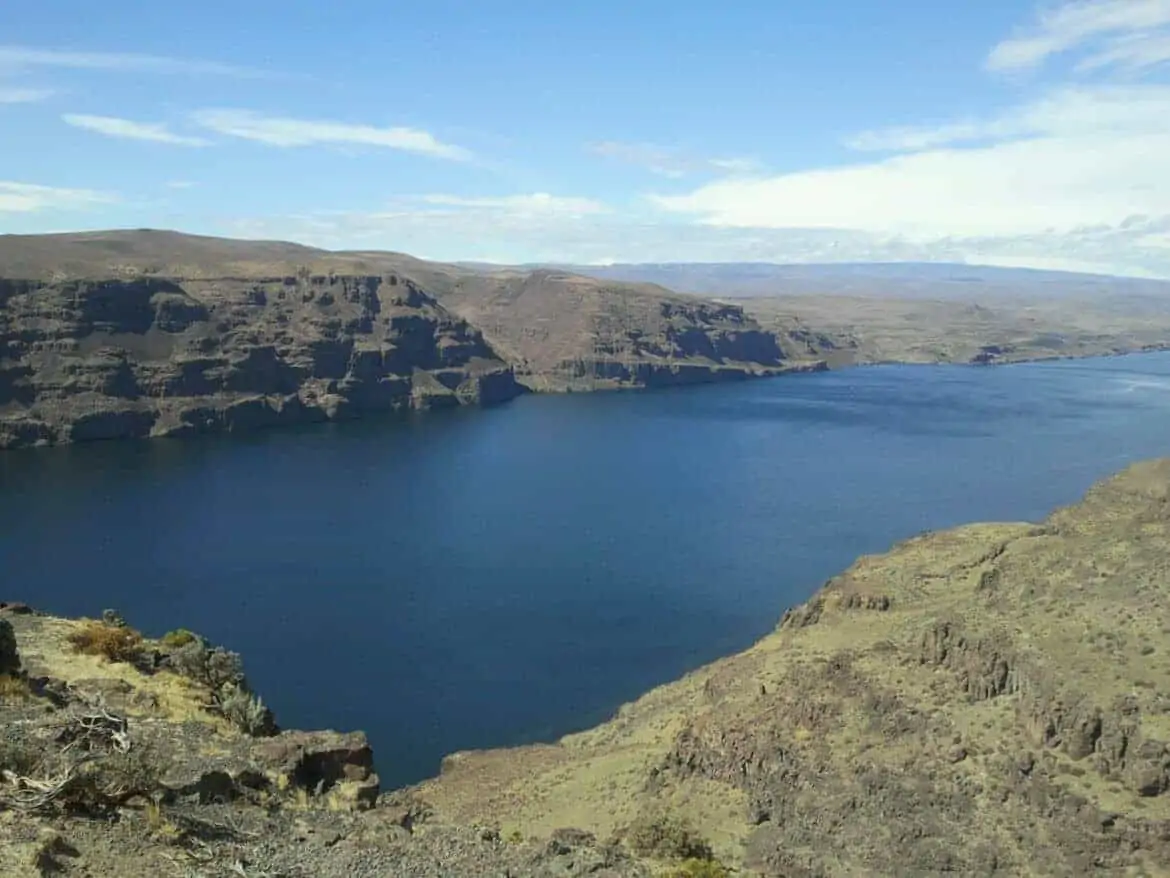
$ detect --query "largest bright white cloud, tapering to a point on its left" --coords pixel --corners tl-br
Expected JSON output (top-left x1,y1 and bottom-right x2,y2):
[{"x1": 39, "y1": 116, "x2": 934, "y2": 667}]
[{"x1": 651, "y1": 85, "x2": 1170, "y2": 250}]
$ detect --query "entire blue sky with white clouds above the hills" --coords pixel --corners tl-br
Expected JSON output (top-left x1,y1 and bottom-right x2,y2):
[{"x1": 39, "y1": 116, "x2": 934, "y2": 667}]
[{"x1": 0, "y1": 0, "x2": 1170, "y2": 277}]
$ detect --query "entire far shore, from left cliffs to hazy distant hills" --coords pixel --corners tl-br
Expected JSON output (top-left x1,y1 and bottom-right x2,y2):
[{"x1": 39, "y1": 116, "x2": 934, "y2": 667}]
[{"x1": 0, "y1": 229, "x2": 1170, "y2": 447}]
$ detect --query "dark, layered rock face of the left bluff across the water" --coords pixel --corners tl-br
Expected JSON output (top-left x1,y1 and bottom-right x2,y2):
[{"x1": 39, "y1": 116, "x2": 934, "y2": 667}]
[{"x1": 0, "y1": 272, "x2": 521, "y2": 448}]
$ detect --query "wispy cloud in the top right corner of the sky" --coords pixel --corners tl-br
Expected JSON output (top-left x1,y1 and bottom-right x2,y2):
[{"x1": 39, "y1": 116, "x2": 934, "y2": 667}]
[{"x1": 986, "y1": 0, "x2": 1170, "y2": 71}]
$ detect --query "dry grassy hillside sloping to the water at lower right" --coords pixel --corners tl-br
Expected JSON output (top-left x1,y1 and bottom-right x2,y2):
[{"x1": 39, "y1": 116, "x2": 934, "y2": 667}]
[{"x1": 418, "y1": 460, "x2": 1170, "y2": 878}]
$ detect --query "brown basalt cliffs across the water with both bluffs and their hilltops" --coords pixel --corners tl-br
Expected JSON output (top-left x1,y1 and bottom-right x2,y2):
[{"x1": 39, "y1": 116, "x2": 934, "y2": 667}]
[{"x1": 0, "y1": 231, "x2": 824, "y2": 448}]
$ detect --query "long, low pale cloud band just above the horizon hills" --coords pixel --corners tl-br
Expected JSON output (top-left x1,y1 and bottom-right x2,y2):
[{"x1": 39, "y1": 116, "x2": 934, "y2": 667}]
[{"x1": 217, "y1": 208, "x2": 1170, "y2": 277}]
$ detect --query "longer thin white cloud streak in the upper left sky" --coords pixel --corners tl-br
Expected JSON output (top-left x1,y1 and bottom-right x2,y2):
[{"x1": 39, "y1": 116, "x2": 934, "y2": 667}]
[{"x1": 192, "y1": 109, "x2": 473, "y2": 162}]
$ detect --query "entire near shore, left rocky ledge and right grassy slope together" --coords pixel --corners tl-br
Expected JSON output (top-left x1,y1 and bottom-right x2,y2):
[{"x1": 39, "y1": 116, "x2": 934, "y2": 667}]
[{"x1": 0, "y1": 460, "x2": 1170, "y2": 878}]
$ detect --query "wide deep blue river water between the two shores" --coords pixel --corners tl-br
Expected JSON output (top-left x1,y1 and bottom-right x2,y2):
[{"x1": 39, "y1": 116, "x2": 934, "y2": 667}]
[{"x1": 0, "y1": 354, "x2": 1170, "y2": 784}]
